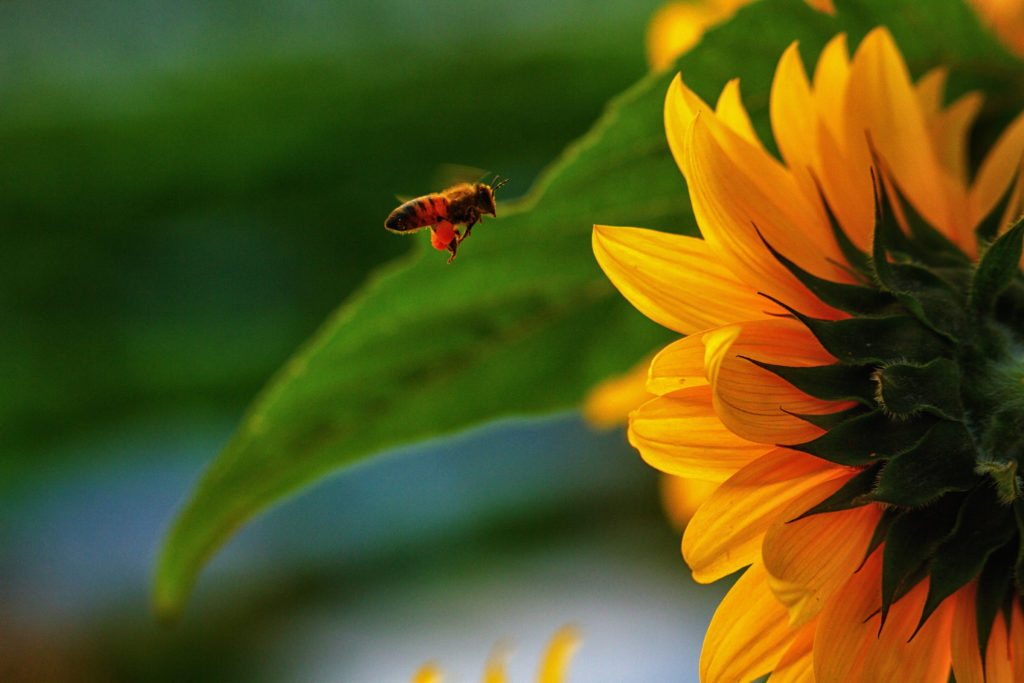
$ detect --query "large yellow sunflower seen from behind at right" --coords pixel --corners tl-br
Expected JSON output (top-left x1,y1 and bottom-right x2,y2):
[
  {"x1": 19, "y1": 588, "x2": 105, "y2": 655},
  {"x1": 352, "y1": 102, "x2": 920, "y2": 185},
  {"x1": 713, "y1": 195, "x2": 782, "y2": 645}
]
[{"x1": 593, "y1": 29, "x2": 1024, "y2": 683}]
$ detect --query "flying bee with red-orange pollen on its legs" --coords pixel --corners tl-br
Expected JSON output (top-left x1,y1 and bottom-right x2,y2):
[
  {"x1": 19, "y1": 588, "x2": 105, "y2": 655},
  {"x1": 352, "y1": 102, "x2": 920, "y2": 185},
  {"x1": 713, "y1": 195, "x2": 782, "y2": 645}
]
[{"x1": 384, "y1": 176, "x2": 508, "y2": 263}]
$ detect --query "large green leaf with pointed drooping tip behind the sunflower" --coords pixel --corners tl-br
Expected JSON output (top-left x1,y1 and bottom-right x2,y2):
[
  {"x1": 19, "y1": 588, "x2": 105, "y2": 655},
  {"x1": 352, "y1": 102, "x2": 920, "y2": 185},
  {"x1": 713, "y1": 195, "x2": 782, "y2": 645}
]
[{"x1": 155, "y1": 0, "x2": 1014, "y2": 616}]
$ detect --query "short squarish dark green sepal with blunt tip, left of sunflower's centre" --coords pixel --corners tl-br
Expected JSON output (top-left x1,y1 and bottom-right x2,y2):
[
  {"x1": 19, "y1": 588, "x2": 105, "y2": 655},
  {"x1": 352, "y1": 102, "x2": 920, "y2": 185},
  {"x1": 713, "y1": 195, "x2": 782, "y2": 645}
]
[{"x1": 872, "y1": 358, "x2": 964, "y2": 420}]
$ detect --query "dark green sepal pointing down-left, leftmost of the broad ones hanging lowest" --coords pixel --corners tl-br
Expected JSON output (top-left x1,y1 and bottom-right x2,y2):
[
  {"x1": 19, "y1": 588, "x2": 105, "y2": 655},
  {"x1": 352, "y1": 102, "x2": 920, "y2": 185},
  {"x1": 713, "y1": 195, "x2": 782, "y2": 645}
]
[{"x1": 882, "y1": 495, "x2": 965, "y2": 624}]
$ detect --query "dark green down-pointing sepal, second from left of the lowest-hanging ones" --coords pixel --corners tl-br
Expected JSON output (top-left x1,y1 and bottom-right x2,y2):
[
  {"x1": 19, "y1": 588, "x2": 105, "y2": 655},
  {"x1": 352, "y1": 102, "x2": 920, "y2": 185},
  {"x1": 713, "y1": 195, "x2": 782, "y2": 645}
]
[{"x1": 918, "y1": 485, "x2": 1017, "y2": 629}]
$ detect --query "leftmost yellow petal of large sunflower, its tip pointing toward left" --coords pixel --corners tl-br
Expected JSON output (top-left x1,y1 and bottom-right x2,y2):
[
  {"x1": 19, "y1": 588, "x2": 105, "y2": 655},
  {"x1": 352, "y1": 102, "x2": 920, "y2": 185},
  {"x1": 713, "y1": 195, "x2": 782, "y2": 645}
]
[{"x1": 593, "y1": 225, "x2": 778, "y2": 334}]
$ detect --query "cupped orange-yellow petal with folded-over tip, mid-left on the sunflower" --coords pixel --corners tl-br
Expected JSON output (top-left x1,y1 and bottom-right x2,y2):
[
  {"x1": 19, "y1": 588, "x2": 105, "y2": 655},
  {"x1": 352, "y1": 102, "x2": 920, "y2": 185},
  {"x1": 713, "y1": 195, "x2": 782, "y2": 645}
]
[{"x1": 702, "y1": 317, "x2": 852, "y2": 444}]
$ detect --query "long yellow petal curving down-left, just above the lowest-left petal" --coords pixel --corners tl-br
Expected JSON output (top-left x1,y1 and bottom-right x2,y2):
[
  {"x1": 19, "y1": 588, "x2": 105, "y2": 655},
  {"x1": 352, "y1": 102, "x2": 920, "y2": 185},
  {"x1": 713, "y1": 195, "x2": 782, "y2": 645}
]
[{"x1": 683, "y1": 449, "x2": 844, "y2": 584}]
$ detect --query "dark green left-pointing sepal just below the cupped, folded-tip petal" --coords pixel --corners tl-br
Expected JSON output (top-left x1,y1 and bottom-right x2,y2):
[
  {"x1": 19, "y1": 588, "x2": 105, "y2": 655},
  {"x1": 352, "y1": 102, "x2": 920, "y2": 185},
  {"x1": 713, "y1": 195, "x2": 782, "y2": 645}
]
[{"x1": 788, "y1": 410, "x2": 936, "y2": 466}]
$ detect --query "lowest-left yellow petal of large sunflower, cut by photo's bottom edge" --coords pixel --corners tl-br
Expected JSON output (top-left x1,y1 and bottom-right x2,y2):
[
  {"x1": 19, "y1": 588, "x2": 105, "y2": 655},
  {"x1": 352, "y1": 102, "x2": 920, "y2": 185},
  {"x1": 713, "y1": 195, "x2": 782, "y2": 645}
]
[{"x1": 700, "y1": 562, "x2": 796, "y2": 683}]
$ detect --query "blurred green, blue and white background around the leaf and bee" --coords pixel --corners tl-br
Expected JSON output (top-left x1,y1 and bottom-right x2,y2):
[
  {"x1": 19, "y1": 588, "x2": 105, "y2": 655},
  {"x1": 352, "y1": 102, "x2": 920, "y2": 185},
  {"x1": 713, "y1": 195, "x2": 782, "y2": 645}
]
[{"x1": 0, "y1": 0, "x2": 720, "y2": 681}]
